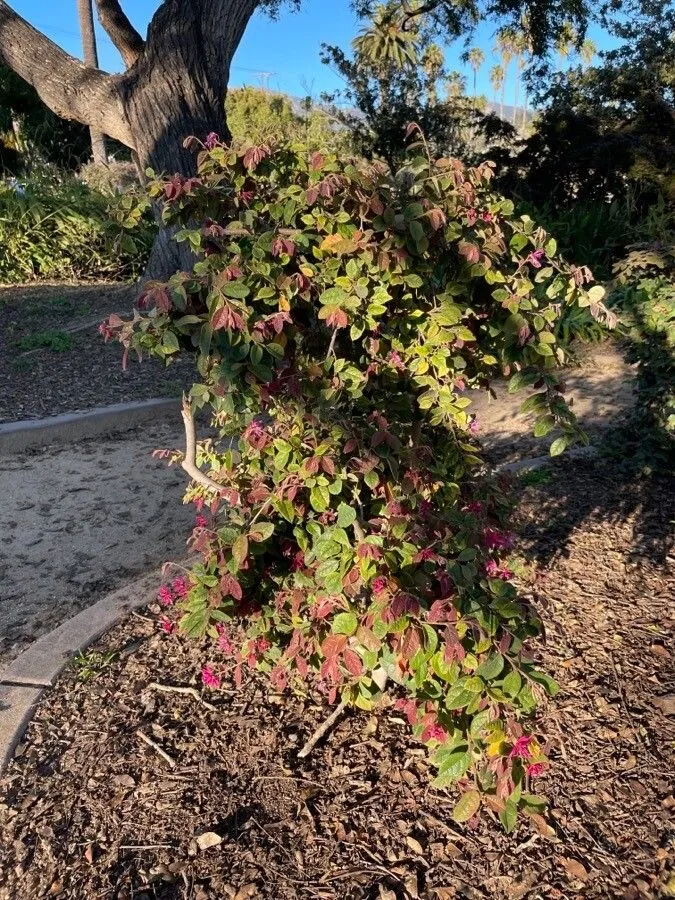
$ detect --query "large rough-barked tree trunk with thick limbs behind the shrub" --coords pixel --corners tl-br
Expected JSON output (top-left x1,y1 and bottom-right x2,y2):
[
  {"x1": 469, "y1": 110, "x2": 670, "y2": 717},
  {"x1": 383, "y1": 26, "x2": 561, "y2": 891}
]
[{"x1": 0, "y1": 0, "x2": 260, "y2": 279}]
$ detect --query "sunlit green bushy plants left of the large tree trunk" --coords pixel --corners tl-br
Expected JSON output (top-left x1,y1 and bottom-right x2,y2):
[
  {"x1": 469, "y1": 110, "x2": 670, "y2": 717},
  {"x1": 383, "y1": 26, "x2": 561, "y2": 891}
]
[{"x1": 0, "y1": 173, "x2": 154, "y2": 284}]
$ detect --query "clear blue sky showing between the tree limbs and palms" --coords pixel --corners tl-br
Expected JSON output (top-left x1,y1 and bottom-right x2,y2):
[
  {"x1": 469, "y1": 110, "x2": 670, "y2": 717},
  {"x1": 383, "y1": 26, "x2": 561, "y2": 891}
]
[{"x1": 9, "y1": 0, "x2": 603, "y2": 103}]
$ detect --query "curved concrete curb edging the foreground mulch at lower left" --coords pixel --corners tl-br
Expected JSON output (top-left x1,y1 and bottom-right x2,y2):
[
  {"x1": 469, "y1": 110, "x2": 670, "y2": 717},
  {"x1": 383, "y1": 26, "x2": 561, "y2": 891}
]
[{"x1": 0, "y1": 569, "x2": 162, "y2": 773}]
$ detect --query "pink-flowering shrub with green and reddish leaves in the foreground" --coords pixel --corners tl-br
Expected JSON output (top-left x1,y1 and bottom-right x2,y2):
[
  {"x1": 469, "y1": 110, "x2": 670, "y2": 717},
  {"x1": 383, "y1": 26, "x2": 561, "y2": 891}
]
[{"x1": 103, "y1": 136, "x2": 603, "y2": 829}]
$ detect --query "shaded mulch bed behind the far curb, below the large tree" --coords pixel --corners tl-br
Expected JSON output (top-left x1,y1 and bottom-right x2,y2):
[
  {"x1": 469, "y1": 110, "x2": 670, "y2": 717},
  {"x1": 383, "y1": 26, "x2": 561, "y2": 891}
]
[{"x1": 0, "y1": 283, "x2": 192, "y2": 422}]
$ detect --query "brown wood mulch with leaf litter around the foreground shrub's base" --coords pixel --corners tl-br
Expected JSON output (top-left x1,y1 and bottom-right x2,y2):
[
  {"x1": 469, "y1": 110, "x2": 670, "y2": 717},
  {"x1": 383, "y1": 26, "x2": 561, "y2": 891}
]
[{"x1": 0, "y1": 462, "x2": 675, "y2": 900}]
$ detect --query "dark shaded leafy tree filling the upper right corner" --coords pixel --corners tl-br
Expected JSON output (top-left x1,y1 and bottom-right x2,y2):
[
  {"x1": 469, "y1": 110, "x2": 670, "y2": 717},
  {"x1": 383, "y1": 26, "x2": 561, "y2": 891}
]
[{"x1": 511, "y1": 0, "x2": 675, "y2": 209}]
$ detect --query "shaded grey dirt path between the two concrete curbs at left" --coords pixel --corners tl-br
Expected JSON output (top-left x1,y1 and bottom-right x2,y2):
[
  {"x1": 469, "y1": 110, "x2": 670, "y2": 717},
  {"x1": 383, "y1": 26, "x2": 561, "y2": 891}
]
[{"x1": 0, "y1": 426, "x2": 192, "y2": 666}]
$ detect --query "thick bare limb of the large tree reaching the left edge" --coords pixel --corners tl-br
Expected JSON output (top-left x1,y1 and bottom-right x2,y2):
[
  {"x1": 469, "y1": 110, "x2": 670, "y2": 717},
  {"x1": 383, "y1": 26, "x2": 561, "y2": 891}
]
[{"x1": 0, "y1": 0, "x2": 134, "y2": 148}]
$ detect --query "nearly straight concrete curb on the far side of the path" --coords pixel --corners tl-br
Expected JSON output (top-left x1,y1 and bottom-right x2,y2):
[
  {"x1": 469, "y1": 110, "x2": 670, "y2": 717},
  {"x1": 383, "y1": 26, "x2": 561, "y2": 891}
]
[{"x1": 0, "y1": 399, "x2": 180, "y2": 456}]
